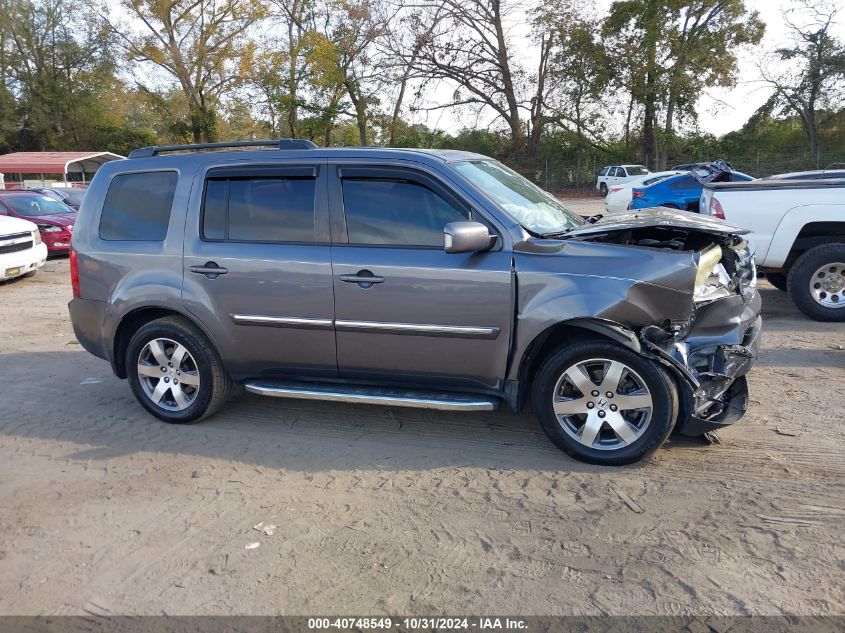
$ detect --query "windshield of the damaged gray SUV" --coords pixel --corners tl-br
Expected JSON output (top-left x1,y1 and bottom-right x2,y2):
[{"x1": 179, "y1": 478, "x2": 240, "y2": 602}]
[{"x1": 454, "y1": 160, "x2": 584, "y2": 235}]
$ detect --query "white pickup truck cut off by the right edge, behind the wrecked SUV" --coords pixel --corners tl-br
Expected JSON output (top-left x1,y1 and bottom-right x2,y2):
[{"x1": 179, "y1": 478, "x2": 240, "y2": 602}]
[{"x1": 700, "y1": 178, "x2": 845, "y2": 321}]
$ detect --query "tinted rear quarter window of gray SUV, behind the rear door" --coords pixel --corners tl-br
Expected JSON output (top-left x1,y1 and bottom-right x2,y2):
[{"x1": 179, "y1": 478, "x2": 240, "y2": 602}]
[{"x1": 100, "y1": 171, "x2": 179, "y2": 242}]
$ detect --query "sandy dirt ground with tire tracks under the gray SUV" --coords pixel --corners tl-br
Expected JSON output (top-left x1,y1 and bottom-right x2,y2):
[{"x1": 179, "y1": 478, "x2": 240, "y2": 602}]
[{"x1": 0, "y1": 254, "x2": 845, "y2": 616}]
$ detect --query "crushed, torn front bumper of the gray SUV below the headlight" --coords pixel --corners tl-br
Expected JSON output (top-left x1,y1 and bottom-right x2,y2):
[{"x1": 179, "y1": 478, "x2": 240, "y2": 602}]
[{"x1": 640, "y1": 291, "x2": 762, "y2": 436}]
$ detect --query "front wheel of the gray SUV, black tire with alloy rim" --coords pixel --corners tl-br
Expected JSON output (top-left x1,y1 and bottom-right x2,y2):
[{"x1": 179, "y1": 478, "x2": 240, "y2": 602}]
[{"x1": 533, "y1": 341, "x2": 678, "y2": 466}]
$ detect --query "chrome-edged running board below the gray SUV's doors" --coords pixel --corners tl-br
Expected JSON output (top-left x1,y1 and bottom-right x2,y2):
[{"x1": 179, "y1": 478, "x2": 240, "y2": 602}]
[{"x1": 244, "y1": 380, "x2": 499, "y2": 411}]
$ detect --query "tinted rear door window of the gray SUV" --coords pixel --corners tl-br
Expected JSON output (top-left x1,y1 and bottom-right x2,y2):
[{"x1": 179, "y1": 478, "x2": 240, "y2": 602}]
[{"x1": 202, "y1": 176, "x2": 317, "y2": 242}]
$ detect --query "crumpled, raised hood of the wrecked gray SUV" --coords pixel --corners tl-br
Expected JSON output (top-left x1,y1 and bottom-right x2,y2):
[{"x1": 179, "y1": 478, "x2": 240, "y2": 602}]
[{"x1": 566, "y1": 207, "x2": 749, "y2": 237}]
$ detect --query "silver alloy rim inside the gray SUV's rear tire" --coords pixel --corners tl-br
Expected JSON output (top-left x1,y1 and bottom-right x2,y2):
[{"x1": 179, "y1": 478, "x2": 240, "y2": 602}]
[{"x1": 138, "y1": 338, "x2": 200, "y2": 411}]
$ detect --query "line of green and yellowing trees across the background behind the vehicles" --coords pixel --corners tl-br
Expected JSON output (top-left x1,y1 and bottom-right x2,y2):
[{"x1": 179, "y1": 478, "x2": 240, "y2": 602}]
[{"x1": 0, "y1": 0, "x2": 845, "y2": 189}]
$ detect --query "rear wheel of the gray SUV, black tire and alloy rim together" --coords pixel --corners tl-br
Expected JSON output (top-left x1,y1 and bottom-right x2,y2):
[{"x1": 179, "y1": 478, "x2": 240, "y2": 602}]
[{"x1": 126, "y1": 317, "x2": 231, "y2": 424}]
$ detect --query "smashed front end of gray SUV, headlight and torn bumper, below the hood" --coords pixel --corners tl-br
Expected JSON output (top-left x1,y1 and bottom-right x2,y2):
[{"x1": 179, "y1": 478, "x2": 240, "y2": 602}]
[{"x1": 564, "y1": 214, "x2": 762, "y2": 436}]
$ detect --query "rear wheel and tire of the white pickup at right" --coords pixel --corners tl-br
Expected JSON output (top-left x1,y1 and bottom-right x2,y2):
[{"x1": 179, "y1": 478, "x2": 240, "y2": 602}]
[{"x1": 787, "y1": 243, "x2": 845, "y2": 322}]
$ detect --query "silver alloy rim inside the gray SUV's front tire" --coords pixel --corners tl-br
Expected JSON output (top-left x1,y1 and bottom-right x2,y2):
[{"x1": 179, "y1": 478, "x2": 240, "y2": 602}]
[{"x1": 552, "y1": 358, "x2": 654, "y2": 450}]
